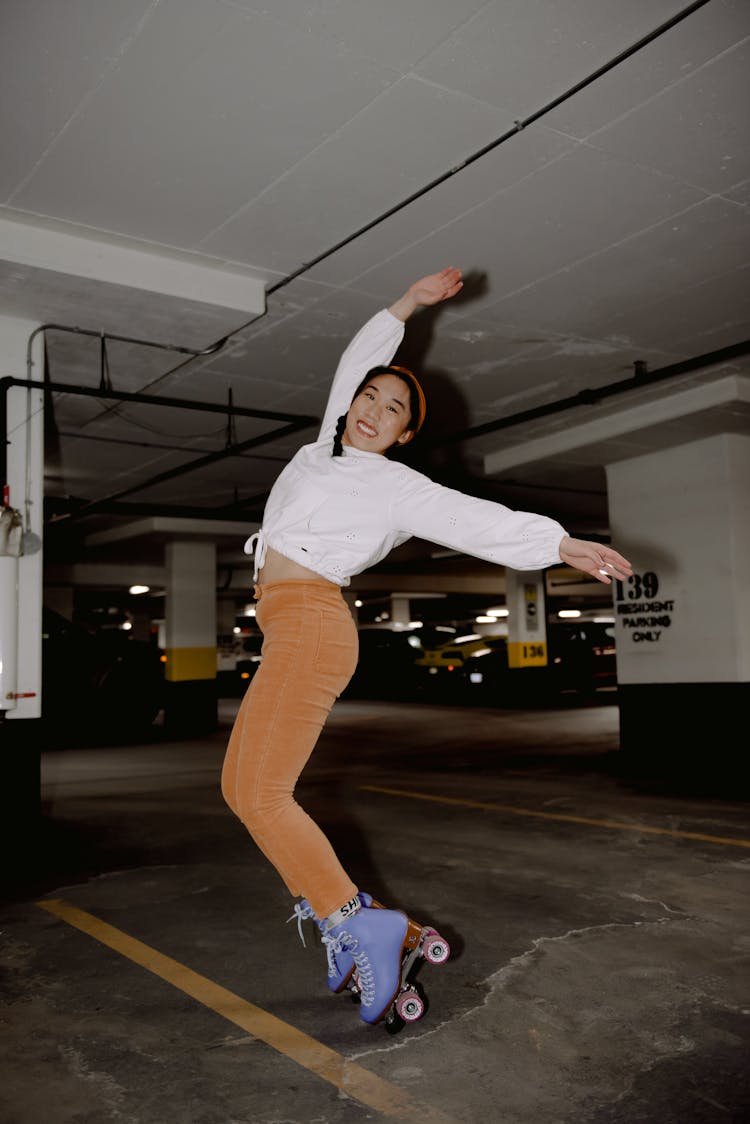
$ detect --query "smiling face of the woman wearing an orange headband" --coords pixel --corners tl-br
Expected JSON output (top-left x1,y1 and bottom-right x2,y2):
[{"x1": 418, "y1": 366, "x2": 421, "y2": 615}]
[{"x1": 341, "y1": 374, "x2": 412, "y2": 453}]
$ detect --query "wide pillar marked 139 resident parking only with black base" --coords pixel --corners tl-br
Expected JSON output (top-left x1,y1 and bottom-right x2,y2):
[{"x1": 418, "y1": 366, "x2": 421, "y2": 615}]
[{"x1": 607, "y1": 433, "x2": 750, "y2": 794}]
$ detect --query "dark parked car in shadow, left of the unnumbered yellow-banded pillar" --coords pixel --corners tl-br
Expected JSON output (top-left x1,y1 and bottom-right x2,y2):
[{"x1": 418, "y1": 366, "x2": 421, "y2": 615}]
[{"x1": 42, "y1": 607, "x2": 165, "y2": 737}]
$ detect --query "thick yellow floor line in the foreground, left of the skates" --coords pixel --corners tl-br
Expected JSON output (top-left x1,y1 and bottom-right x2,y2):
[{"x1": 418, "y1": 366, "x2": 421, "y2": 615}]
[{"x1": 37, "y1": 899, "x2": 455, "y2": 1124}]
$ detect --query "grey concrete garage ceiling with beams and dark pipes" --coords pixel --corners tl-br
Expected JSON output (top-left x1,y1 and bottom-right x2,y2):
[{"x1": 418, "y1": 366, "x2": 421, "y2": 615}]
[{"x1": 0, "y1": 0, "x2": 750, "y2": 611}]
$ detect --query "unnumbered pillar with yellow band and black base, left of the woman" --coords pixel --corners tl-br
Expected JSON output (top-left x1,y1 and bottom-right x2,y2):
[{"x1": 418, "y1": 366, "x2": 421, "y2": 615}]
[{"x1": 164, "y1": 542, "x2": 217, "y2": 735}]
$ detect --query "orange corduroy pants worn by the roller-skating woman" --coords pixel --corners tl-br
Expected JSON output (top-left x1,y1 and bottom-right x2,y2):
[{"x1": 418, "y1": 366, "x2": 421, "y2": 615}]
[{"x1": 222, "y1": 579, "x2": 359, "y2": 918}]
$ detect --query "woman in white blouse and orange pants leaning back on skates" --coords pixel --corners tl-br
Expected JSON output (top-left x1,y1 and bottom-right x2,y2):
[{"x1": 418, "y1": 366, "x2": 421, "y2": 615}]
[{"x1": 222, "y1": 266, "x2": 632, "y2": 1023}]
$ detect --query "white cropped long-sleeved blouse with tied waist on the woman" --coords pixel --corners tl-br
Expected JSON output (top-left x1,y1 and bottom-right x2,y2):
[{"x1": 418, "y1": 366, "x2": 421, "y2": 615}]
[{"x1": 245, "y1": 309, "x2": 567, "y2": 586}]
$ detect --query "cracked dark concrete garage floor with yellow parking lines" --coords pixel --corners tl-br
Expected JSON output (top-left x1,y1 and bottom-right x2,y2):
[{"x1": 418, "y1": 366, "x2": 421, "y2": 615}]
[{"x1": 0, "y1": 698, "x2": 750, "y2": 1124}]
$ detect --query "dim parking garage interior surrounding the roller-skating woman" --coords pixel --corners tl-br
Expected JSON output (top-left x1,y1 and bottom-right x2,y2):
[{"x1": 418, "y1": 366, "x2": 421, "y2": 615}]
[{"x1": 0, "y1": 0, "x2": 750, "y2": 1124}]
